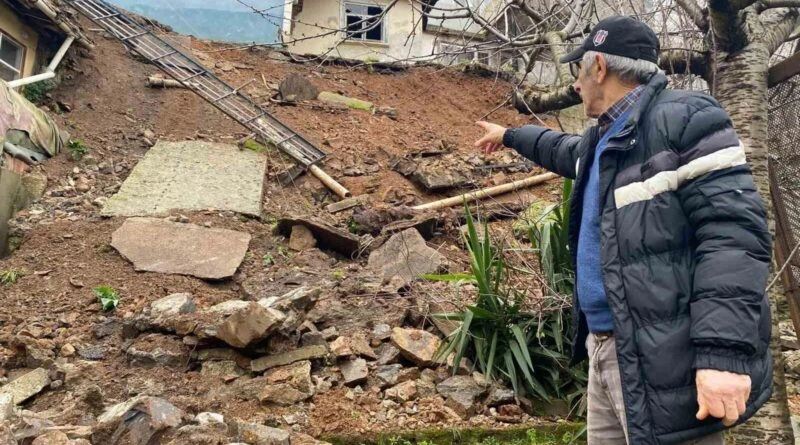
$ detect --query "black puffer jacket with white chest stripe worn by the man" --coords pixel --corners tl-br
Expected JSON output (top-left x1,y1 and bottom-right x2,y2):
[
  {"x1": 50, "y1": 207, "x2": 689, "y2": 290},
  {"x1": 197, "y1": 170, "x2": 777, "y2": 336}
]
[{"x1": 504, "y1": 74, "x2": 772, "y2": 445}]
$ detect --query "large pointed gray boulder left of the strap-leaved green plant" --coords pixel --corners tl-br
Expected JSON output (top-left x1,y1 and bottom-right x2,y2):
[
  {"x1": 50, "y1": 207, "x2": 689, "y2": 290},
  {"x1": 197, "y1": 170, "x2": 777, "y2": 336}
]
[{"x1": 368, "y1": 229, "x2": 446, "y2": 287}]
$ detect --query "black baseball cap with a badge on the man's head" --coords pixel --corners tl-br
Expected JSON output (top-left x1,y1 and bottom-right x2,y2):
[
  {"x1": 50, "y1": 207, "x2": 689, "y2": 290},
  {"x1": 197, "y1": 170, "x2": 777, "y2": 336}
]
[{"x1": 560, "y1": 15, "x2": 661, "y2": 63}]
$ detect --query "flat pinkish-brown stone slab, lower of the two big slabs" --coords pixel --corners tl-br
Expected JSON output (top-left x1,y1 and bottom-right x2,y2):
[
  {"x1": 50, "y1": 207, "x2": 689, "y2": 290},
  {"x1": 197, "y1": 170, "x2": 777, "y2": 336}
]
[{"x1": 111, "y1": 218, "x2": 250, "y2": 280}]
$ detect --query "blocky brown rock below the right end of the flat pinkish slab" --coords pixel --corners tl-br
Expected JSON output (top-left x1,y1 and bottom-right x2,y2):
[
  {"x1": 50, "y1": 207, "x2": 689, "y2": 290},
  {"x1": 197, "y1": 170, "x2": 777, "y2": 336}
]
[{"x1": 217, "y1": 303, "x2": 278, "y2": 348}]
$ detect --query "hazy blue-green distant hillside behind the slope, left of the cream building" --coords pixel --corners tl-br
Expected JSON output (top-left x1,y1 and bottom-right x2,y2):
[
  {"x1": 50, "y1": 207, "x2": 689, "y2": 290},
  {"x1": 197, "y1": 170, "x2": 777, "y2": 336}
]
[{"x1": 106, "y1": 0, "x2": 283, "y2": 43}]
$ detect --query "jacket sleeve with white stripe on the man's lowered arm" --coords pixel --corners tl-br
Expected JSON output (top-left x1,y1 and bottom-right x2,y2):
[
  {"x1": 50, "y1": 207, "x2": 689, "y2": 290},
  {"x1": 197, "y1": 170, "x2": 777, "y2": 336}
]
[{"x1": 662, "y1": 96, "x2": 772, "y2": 374}]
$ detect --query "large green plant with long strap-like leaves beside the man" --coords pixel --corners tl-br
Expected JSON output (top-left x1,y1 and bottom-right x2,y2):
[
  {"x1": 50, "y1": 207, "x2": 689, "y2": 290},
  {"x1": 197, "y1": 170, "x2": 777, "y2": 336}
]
[{"x1": 427, "y1": 201, "x2": 586, "y2": 412}]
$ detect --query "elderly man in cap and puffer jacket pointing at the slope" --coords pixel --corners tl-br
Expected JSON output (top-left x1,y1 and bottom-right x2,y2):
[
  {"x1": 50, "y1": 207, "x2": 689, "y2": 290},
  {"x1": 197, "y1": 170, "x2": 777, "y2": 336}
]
[{"x1": 476, "y1": 17, "x2": 772, "y2": 445}]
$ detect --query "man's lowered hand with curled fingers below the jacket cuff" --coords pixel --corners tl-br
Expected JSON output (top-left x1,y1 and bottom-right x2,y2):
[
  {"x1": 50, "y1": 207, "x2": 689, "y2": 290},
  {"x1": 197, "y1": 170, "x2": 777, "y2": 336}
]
[{"x1": 695, "y1": 369, "x2": 751, "y2": 426}]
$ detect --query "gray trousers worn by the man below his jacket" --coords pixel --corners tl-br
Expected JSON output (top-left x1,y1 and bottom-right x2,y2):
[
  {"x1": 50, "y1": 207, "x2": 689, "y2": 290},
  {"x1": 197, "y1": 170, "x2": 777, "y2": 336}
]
[{"x1": 586, "y1": 334, "x2": 725, "y2": 445}]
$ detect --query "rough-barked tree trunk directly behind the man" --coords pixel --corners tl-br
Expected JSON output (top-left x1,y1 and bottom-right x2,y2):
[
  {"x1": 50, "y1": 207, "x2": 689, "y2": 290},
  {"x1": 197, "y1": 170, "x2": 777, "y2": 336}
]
[{"x1": 713, "y1": 29, "x2": 794, "y2": 445}]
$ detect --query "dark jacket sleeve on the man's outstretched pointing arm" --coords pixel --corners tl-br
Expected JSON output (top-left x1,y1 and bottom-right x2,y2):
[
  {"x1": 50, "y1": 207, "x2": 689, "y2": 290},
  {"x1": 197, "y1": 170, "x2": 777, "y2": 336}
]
[{"x1": 503, "y1": 125, "x2": 581, "y2": 179}]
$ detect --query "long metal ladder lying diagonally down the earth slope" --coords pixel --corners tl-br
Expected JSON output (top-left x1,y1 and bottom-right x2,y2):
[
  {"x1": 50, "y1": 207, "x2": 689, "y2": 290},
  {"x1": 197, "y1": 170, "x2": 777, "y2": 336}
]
[{"x1": 62, "y1": 0, "x2": 324, "y2": 167}]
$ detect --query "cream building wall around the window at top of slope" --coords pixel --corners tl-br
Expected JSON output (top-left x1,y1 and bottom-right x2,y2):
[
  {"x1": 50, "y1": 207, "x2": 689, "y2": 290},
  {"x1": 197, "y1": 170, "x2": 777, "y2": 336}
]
[{"x1": 284, "y1": 0, "x2": 436, "y2": 62}]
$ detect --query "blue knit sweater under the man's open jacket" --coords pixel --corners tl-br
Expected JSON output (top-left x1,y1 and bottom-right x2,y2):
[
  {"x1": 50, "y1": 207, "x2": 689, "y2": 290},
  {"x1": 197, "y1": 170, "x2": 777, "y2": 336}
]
[{"x1": 576, "y1": 111, "x2": 630, "y2": 332}]
